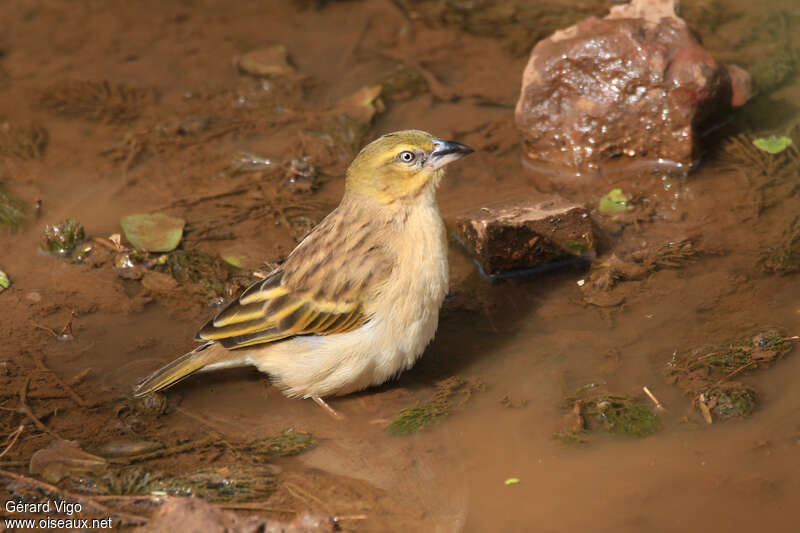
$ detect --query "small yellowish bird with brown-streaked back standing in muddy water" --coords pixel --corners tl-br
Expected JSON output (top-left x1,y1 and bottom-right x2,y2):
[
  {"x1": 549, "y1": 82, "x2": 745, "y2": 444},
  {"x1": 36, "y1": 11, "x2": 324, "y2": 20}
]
[{"x1": 134, "y1": 130, "x2": 474, "y2": 416}]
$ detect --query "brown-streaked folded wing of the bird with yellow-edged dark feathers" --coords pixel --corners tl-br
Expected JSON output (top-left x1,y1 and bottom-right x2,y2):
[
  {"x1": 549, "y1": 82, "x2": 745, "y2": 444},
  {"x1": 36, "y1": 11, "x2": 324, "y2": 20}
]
[{"x1": 196, "y1": 204, "x2": 394, "y2": 349}]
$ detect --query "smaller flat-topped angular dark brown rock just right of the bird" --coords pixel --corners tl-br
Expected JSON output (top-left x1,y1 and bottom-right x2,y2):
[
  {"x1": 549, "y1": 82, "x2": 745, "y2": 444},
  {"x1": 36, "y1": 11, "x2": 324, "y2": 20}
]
[{"x1": 456, "y1": 197, "x2": 595, "y2": 276}]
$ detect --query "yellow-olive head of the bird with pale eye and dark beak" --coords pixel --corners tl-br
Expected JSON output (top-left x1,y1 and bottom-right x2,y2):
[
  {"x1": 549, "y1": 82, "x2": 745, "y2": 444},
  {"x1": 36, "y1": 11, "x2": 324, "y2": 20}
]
[{"x1": 346, "y1": 130, "x2": 474, "y2": 203}]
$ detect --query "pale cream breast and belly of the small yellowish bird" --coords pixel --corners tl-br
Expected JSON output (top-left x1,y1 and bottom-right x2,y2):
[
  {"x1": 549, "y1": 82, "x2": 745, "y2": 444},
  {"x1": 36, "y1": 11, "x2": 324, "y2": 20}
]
[{"x1": 248, "y1": 200, "x2": 448, "y2": 397}]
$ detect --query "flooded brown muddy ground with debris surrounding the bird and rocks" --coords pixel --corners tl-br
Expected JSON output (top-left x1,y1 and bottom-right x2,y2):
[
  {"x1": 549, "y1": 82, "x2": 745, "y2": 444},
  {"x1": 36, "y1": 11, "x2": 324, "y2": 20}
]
[{"x1": 0, "y1": 0, "x2": 800, "y2": 532}]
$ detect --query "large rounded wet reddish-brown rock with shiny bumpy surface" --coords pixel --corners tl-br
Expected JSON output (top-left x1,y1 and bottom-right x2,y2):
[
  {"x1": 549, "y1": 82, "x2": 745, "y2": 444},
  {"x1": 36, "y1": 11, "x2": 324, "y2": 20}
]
[{"x1": 515, "y1": 0, "x2": 751, "y2": 170}]
